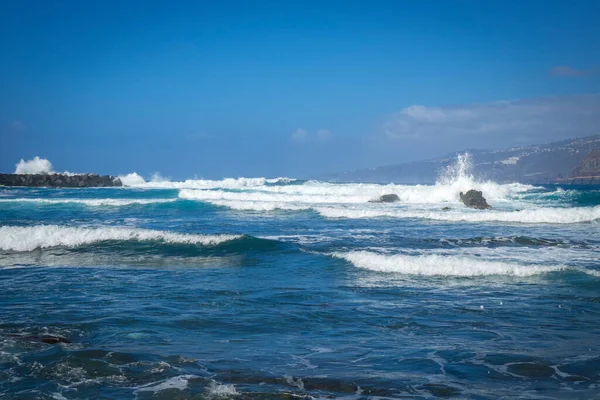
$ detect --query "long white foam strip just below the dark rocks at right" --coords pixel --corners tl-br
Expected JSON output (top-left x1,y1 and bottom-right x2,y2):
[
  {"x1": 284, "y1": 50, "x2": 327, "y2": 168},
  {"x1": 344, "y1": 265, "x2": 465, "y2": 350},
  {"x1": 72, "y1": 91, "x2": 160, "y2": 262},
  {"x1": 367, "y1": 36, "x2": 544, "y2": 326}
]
[{"x1": 316, "y1": 206, "x2": 600, "y2": 224}]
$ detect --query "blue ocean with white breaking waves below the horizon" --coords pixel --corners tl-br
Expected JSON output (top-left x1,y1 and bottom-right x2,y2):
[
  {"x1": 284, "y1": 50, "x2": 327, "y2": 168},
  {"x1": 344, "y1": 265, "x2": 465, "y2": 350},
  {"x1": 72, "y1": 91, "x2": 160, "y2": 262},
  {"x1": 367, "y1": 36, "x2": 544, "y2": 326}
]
[{"x1": 0, "y1": 159, "x2": 600, "y2": 400}]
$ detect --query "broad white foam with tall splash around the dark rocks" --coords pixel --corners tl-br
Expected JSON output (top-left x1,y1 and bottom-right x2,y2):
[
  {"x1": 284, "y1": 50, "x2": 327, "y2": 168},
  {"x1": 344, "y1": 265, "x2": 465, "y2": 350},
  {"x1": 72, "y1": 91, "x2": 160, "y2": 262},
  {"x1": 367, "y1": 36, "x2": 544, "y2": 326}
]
[{"x1": 173, "y1": 155, "x2": 535, "y2": 215}]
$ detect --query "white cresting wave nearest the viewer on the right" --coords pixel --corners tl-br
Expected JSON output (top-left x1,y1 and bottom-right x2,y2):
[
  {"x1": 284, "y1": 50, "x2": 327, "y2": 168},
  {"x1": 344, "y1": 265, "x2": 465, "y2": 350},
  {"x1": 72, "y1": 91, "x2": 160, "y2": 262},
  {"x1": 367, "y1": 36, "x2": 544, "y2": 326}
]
[{"x1": 333, "y1": 251, "x2": 600, "y2": 277}]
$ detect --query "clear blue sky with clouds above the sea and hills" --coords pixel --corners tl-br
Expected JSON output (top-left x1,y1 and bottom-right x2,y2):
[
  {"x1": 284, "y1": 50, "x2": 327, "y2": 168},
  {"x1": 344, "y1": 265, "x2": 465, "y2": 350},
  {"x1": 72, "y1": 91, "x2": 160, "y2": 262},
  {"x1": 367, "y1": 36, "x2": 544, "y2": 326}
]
[{"x1": 0, "y1": 0, "x2": 600, "y2": 178}]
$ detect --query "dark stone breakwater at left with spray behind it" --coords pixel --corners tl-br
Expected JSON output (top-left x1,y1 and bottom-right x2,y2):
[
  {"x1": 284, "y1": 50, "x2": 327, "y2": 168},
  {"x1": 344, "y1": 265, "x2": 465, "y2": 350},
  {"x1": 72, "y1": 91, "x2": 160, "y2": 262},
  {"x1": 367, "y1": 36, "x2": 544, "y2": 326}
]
[{"x1": 0, "y1": 174, "x2": 123, "y2": 187}]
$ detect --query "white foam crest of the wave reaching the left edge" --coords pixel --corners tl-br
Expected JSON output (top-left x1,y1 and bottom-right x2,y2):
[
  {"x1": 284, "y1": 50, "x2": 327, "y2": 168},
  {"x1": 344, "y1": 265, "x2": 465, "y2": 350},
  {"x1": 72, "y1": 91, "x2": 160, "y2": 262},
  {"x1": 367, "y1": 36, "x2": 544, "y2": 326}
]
[{"x1": 0, "y1": 225, "x2": 241, "y2": 251}]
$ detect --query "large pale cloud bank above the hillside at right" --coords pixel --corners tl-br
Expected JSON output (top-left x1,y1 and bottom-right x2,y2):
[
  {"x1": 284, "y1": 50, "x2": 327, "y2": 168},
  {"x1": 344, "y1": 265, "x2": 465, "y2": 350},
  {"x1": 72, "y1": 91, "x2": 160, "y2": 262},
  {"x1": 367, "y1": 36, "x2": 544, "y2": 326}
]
[{"x1": 383, "y1": 95, "x2": 600, "y2": 147}]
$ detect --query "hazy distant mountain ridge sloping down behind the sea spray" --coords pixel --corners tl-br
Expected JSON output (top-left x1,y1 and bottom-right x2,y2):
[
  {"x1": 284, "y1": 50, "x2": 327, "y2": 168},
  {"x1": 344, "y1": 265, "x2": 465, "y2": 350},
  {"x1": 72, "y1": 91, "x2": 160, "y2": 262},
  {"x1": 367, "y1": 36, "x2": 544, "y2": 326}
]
[{"x1": 319, "y1": 135, "x2": 600, "y2": 184}]
